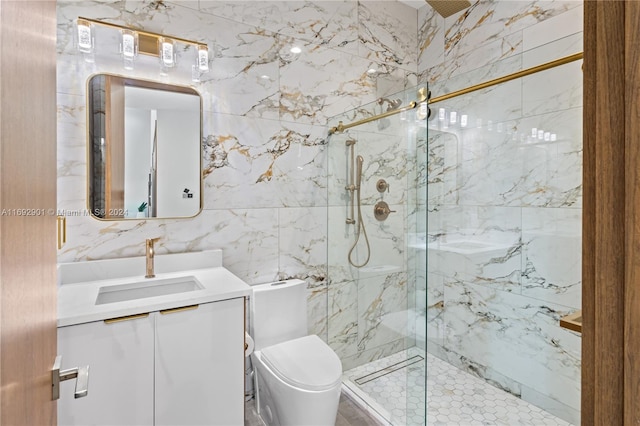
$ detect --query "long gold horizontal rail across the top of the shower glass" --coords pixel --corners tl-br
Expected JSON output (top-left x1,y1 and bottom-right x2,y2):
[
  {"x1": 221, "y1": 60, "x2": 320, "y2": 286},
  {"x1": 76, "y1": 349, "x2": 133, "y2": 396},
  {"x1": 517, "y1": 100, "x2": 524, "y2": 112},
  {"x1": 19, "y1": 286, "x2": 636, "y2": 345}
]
[{"x1": 329, "y1": 52, "x2": 584, "y2": 135}]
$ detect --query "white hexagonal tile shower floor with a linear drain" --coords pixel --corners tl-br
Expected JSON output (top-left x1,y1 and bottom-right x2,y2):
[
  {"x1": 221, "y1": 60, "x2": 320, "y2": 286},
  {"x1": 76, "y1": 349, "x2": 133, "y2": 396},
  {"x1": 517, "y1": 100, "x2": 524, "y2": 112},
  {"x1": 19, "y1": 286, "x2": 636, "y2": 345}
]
[{"x1": 343, "y1": 348, "x2": 569, "y2": 426}]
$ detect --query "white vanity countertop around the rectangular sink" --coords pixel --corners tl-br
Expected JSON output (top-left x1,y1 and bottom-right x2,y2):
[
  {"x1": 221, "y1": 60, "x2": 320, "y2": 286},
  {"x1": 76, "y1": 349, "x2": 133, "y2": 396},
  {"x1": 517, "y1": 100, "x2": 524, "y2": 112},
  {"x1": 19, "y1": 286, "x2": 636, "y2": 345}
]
[{"x1": 58, "y1": 250, "x2": 251, "y2": 327}]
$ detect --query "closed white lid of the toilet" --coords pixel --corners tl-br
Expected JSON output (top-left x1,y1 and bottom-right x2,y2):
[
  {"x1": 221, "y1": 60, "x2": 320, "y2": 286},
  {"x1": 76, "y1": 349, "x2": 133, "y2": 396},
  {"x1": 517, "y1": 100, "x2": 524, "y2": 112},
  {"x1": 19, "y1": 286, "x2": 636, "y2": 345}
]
[{"x1": 262, "y1": 335, "x2": 342, "y2": 390}]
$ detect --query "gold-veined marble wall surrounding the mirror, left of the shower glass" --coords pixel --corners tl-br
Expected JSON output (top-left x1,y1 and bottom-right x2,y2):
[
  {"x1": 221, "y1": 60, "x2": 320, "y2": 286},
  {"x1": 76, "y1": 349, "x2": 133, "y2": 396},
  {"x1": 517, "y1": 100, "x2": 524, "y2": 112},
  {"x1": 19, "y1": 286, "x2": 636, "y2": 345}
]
[{"x1": 57, "y1": 0, "x2": 418, "y2": 342}]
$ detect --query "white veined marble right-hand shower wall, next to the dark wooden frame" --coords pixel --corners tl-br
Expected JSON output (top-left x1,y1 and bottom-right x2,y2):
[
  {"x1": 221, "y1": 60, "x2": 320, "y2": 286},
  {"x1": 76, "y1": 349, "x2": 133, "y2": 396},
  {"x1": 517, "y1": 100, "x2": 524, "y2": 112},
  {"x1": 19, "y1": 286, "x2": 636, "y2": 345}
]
[{"x1": 418, "y1": 1, "x2": 582, "y2": 424}]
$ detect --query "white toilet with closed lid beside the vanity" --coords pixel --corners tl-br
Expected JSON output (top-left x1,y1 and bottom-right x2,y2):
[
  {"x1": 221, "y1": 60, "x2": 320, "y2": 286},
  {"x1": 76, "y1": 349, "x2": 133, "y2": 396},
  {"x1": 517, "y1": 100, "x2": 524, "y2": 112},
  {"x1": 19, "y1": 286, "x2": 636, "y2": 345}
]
[{"x1": 250, "y1": 280, "x2": 342, "y2": 426}]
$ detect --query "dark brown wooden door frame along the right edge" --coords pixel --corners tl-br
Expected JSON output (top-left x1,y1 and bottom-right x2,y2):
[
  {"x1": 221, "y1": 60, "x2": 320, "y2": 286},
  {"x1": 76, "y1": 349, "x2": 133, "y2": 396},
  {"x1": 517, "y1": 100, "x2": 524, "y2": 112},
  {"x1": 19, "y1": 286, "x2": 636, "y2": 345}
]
[{"x1": 581, "y1": 0, "x2": 640, "y2": 426}]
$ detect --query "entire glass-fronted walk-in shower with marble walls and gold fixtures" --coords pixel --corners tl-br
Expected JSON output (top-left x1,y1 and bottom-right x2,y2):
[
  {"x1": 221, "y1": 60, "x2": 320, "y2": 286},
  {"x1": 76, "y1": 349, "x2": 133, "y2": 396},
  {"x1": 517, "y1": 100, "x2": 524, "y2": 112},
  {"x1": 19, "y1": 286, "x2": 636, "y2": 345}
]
[{"x1": 328, "y1": 34, "x2": 582, "y2": 425}]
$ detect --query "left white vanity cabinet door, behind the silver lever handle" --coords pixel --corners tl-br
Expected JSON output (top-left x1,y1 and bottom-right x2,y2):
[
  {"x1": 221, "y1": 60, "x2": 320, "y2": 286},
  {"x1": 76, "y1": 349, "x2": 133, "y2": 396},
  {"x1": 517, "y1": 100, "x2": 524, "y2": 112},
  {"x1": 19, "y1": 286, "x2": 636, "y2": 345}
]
[{"x1": 58, "y1": 314, "x2": 154, "y2": 426}]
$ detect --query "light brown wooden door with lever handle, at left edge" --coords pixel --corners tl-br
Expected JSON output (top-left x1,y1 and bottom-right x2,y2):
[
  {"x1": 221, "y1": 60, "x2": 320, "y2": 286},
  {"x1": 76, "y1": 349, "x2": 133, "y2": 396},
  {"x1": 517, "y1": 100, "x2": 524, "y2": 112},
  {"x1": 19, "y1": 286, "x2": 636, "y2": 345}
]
[{"x1": 0, "y1": 0, "x2": 56, "y2": 426}]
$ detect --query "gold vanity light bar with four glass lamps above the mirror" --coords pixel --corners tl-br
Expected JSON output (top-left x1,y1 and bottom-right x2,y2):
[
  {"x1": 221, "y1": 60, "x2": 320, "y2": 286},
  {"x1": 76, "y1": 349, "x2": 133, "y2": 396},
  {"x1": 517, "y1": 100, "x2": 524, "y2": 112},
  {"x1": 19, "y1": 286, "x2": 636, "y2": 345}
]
[{"x1": 76, "y1": 17, "x2": 209, "y2": 81}]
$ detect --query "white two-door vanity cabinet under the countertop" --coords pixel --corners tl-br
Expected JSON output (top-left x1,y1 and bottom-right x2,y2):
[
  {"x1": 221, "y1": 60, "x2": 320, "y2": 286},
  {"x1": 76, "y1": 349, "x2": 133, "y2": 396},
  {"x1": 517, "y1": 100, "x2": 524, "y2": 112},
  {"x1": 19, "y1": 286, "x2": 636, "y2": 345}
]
[{"x1": 58, "y1": 297, "x2": 244, "y2": 426}]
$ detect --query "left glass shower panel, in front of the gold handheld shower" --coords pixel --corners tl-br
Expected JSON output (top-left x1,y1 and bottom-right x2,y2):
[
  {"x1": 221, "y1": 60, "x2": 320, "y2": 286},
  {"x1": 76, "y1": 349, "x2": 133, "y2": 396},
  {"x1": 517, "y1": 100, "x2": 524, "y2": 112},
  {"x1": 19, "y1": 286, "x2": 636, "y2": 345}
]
[{"x1": 328, "y1": 85, "x2": 427, "y2": 425}]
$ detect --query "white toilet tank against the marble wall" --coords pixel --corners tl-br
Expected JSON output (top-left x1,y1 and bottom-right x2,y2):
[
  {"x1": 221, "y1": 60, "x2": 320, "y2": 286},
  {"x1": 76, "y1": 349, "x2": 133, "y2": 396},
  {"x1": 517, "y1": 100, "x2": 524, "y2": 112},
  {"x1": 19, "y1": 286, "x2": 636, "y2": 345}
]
[{"x1": 249, "y1": 280, "x2": 309, "y2": 350}]
